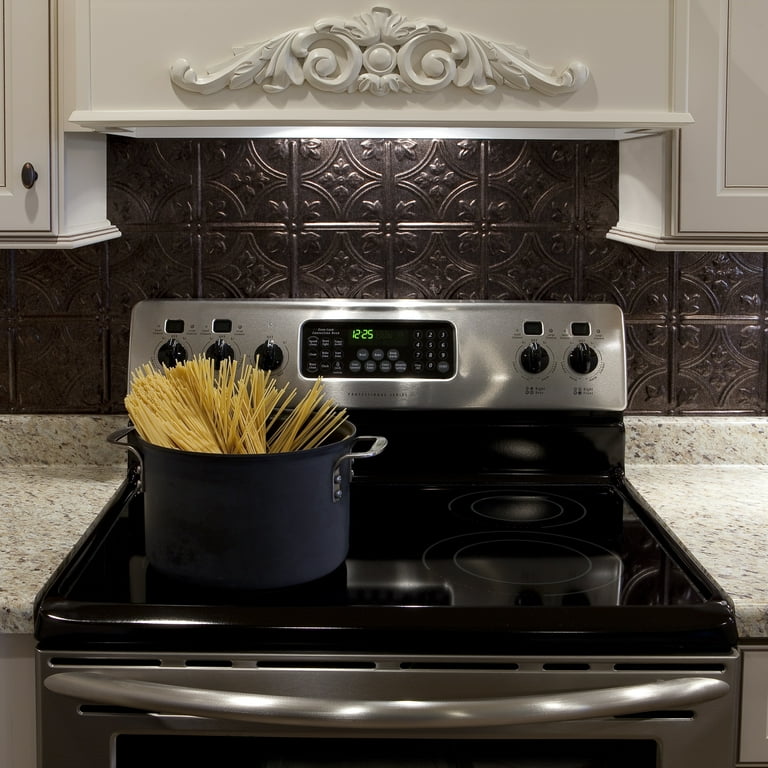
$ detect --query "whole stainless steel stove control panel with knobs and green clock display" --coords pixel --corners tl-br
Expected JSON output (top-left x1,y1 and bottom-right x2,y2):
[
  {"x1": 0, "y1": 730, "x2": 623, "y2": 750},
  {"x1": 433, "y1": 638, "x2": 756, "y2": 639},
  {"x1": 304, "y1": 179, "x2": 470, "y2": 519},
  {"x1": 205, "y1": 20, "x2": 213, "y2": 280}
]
[{"x1": 128, "y1": 299, "x2": 626, "y2": 411}]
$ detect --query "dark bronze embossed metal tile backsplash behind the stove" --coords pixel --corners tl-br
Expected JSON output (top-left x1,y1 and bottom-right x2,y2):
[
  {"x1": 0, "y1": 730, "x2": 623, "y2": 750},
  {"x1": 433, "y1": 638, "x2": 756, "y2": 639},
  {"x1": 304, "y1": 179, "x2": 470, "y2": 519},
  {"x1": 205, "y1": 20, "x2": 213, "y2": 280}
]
[{"x1": 0, "y1": 138, "x2": 768, "y2": 414}]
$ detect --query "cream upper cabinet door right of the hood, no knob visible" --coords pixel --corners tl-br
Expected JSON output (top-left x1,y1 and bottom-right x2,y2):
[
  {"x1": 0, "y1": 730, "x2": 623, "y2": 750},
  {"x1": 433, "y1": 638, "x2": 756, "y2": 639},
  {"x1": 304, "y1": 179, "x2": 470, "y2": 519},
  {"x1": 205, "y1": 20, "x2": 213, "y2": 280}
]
[{"x1": 679, "y1": 0, "x2": 768, "y2": 236}]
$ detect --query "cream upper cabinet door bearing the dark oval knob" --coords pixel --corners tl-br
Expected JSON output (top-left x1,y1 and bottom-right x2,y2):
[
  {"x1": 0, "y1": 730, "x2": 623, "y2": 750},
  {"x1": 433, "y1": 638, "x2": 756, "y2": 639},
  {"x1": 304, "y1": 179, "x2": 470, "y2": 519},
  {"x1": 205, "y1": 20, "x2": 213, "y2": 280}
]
[{"x1": 0, "y1": 0, "x2": 51, "y2": 232}]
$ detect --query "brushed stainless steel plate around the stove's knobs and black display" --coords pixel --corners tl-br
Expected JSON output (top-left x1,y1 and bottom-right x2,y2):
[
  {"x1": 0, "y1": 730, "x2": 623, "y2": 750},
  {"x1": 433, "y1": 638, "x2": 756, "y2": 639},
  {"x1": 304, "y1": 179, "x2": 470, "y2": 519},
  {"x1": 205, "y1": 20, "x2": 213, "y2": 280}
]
[{"x1": 128, "y1": 299, "x2": 627, "y2": 411}]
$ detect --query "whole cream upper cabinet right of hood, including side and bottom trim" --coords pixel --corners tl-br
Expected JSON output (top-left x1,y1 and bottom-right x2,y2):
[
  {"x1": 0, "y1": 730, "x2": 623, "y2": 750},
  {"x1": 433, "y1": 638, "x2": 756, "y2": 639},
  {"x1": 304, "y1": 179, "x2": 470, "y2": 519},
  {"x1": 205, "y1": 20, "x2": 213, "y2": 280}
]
[{"x1": 609, "y1": 0, "x2": 768, "y2": 251}]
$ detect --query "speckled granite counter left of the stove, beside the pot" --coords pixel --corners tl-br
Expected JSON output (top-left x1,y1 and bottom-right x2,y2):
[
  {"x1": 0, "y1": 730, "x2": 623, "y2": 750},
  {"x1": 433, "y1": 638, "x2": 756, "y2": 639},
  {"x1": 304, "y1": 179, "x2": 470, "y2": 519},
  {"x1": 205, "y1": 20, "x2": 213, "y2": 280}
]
[{"x1": 0, "y1": 415, "x2": 126, "y2": 633}]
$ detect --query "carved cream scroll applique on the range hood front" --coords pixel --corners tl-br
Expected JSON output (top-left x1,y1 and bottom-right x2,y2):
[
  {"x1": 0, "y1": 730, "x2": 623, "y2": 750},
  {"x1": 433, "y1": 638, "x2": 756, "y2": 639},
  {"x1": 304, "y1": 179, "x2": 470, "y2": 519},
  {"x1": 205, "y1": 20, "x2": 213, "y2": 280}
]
[{"x1": 171, "y1": 7, "x2": 589, "y2": 96}]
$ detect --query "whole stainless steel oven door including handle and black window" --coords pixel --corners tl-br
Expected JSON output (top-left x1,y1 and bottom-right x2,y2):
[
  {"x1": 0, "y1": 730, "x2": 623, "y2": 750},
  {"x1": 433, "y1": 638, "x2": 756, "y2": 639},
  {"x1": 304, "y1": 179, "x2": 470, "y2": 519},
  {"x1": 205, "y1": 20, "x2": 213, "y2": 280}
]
[{"x1": 38, "y1": 652, "x2": 738, "y2": 768}]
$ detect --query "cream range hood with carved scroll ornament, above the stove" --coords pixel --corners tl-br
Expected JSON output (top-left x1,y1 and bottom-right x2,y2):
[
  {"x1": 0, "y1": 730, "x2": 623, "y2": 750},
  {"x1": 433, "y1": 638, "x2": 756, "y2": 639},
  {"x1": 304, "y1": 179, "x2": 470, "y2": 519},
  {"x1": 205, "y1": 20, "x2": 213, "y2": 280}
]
[{"x1": 66, "y1": 0, "x2": 690, "y2": 138}]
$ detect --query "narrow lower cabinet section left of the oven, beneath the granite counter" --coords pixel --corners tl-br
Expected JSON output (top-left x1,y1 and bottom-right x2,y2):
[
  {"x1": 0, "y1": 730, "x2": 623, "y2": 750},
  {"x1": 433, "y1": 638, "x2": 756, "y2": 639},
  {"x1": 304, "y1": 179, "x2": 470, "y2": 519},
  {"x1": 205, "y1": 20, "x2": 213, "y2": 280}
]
[{"x1": 0, "y1": 633, "x2": 37, "y2": 768}]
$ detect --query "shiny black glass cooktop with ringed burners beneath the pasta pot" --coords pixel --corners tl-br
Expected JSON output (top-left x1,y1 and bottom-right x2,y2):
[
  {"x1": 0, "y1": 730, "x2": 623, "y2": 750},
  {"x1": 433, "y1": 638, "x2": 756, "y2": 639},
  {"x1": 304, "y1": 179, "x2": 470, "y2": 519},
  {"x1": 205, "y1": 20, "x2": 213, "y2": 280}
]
[{"x1": 36, "y1": 482, "x2": 736, "y2": 653}]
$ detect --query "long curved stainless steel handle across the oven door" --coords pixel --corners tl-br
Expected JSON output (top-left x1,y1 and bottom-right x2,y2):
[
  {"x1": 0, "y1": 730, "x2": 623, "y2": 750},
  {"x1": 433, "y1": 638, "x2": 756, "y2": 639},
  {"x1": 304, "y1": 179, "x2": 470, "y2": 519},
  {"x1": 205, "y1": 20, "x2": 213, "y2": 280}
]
[{"x1": 45, "y1": 671, "x2": 730, "y2": 729}]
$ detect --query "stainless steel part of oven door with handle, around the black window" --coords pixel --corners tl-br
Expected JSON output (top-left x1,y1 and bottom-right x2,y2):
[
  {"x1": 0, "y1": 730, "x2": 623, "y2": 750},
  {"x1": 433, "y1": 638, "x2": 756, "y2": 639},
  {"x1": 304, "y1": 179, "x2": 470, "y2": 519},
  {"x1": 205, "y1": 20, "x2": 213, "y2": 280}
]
[{"x1": 37, "y1": 650, "x2": 739, "y2": 768}]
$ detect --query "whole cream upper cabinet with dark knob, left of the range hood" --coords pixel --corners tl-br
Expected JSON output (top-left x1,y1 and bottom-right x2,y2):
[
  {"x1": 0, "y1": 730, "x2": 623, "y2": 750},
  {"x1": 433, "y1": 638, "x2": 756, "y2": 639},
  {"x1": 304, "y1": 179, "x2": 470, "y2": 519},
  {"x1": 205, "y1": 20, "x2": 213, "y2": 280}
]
[{"x1": 0, "y1": 0, "x2": 120, "y2": 248}]
